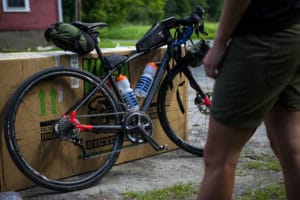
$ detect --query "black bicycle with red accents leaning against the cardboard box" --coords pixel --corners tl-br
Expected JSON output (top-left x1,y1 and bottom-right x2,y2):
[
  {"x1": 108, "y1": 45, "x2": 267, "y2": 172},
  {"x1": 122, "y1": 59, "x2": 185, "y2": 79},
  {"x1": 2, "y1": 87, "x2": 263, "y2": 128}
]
[{"x1": 4, "y1": 6, "x2": 212, "y2": 192}]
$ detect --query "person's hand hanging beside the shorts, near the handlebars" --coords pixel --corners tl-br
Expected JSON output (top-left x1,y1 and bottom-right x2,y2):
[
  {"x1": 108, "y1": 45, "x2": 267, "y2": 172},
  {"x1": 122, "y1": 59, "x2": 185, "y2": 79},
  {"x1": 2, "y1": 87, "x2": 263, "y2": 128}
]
[{"x1": 203, "y1": 44, "x2": 227, "y2": 79}]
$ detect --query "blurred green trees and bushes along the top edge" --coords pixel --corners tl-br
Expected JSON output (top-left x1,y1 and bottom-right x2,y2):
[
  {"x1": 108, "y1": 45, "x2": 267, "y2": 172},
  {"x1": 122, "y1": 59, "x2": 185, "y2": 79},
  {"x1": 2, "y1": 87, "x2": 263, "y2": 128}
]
[{"x1": 62, "y1": 0, "x2": 222, "y2": 25}]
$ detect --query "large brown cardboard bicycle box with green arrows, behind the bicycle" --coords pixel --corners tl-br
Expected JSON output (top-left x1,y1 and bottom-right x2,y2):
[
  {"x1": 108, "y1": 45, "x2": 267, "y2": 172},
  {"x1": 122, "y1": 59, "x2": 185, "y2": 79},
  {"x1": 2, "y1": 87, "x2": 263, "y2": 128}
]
[{"x1": 0, "y1": 49, "x2": 186, "y2": 191}]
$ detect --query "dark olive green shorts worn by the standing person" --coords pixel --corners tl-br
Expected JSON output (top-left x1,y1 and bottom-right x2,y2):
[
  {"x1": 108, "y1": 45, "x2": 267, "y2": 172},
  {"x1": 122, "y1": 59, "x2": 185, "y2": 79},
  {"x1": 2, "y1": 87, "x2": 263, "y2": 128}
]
[{"x1": 211, "y1": 24, "x2": 300, "y2": 128}]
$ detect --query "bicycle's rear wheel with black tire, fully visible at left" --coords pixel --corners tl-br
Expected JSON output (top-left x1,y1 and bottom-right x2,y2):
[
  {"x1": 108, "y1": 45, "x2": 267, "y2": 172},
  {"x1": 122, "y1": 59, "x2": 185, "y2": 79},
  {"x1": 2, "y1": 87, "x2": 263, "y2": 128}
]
[{"x1": 4, "y1": 67, "x2": 123, "y2": 192}]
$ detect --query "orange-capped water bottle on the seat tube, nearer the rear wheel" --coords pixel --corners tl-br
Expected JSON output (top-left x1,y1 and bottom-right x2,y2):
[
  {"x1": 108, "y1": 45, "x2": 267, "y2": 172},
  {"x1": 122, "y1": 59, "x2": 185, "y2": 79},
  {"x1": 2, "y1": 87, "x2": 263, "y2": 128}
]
[{"x1": 117, "y1": 74, "x2": 139, "y2": 110}]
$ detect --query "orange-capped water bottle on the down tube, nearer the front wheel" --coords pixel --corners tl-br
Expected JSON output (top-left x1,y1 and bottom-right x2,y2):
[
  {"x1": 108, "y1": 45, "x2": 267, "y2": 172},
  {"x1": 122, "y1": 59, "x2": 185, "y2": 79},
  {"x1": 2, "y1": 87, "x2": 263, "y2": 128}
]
[{"x1": 135, "y1": 62, "x2": 157, "y2": 98}]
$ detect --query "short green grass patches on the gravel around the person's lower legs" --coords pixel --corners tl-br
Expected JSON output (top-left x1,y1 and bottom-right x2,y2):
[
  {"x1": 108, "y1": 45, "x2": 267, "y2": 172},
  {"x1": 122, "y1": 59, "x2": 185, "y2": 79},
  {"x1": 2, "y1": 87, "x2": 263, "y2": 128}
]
[{"x1": 123, "y1": 152, "x2": 286, "y2": 200}]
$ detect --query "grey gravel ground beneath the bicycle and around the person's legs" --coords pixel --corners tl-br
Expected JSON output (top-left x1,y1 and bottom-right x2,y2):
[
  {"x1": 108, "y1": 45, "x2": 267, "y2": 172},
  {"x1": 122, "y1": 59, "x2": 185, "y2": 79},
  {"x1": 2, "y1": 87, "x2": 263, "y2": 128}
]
[{"x1": 15, "y1": 124, "x2": 282, "y2": 200}]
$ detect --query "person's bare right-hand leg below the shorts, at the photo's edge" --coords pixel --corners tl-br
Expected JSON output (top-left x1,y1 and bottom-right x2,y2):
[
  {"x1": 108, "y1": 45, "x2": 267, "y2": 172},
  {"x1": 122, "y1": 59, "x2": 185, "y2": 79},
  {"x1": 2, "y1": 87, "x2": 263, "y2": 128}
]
[{"x1": 265, "y1": 108, "x2": 300, "y2": 199}]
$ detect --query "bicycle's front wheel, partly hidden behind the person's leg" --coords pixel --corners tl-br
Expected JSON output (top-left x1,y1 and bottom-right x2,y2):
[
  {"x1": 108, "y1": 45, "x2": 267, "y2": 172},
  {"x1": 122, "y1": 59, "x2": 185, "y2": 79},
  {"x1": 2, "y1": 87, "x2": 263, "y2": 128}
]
[{"x1": 157, "y1": 66, "x2": 213, "y2": 156}]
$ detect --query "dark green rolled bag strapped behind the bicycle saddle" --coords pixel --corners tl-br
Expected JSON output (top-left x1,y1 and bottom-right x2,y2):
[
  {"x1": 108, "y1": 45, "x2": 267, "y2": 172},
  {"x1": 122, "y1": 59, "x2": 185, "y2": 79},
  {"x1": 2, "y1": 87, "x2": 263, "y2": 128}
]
[{"x1": 44, "y1": 23, "x2": 95, "y2": 54}]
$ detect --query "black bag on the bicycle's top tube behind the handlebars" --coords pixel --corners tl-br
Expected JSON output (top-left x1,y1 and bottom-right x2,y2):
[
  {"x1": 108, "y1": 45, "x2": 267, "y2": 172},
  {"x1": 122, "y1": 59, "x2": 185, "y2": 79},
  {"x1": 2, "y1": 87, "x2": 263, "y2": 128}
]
[{"x1": 135, "y1": 22, "x2": 167, "y2": 52}]
